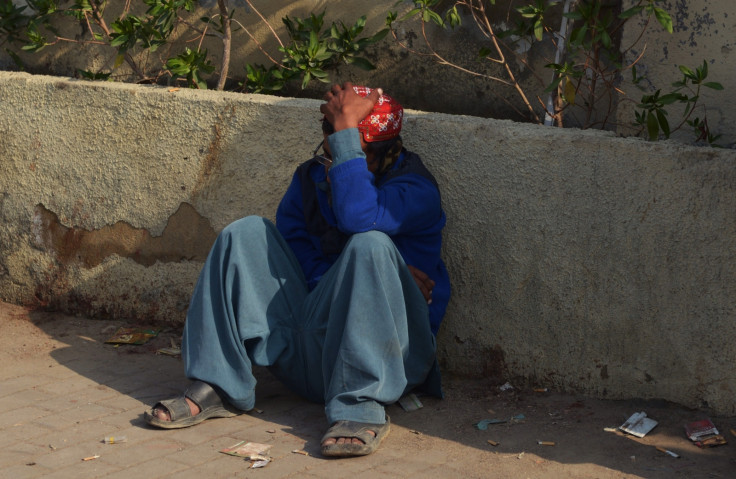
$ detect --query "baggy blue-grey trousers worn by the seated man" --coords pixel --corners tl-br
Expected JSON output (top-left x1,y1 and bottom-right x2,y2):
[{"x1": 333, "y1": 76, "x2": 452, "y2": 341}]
[{"x1": 182, "y1": 216, "x2": 436, "y2": 424}]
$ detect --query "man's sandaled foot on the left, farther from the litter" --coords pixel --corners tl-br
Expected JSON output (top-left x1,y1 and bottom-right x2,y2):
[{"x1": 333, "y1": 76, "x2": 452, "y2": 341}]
[{"x1": 144, "y1": 381, "x2": 243, "y2": 429}]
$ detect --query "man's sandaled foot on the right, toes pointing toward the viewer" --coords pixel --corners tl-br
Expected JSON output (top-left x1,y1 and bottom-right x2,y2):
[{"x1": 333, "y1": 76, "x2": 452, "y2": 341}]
[{"x1": 321, "y1": 416, "x2": 391, "y2": 457}]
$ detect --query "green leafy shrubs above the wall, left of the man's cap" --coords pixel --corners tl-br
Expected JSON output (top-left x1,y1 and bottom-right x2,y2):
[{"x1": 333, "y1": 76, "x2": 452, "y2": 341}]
[{"x1": 0, "y1": 0, "x2": 388, "y2": 93}]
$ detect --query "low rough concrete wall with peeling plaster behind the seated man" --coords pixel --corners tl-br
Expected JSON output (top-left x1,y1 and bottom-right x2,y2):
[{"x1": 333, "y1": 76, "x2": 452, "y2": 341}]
[{"x1": 0, "y1": 73, "x2": 736, "y2": 414}]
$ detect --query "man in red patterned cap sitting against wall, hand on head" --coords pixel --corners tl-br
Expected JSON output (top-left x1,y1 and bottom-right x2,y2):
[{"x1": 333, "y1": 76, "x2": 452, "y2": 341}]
[{"x1": 145, "y1": 83, "x2": 450, "y2": 457}]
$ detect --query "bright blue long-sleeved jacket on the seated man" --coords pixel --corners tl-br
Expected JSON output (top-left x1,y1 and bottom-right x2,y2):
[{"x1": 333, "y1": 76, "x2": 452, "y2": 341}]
[{"x1": 276, "y1": 132, "x2": 450, "y2": 334}]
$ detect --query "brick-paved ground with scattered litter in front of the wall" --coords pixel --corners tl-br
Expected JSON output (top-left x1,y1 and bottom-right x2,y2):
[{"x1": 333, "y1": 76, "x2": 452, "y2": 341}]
[{"x1": 0, "y1": 303, "x2": 736, "y2": 479}]
